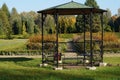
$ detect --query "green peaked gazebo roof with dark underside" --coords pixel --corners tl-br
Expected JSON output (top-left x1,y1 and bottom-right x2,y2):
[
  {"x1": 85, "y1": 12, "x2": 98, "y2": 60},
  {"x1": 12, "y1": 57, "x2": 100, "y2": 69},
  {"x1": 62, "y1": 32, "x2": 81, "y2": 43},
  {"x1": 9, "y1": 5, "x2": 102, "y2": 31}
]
[{"x1": 38, "y1": 1, "x2": 106, "y2": 15}]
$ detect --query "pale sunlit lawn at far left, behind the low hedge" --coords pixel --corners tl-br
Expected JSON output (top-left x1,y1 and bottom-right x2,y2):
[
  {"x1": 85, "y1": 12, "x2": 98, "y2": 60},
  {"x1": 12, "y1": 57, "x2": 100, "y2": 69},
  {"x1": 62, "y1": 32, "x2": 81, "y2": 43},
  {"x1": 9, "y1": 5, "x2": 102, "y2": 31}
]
[{"x1": 0, "y1": 39, "x2": 27, "y2": 50}]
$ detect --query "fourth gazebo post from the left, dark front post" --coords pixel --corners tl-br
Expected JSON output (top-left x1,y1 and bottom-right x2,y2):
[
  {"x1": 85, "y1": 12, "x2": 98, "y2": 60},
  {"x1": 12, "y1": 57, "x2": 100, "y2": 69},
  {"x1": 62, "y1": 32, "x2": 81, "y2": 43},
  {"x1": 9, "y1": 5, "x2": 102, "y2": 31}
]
[{"x1": 90, "y1": 11, "x2": 93, "y2": 67}]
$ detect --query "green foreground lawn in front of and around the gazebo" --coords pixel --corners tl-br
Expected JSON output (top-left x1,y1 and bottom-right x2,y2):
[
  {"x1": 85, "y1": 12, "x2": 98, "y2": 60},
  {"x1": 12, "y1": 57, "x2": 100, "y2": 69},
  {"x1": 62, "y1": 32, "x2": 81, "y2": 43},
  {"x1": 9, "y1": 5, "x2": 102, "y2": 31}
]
[{"x1": 0, "y1": 57, "x2": 120, "y2": 80}]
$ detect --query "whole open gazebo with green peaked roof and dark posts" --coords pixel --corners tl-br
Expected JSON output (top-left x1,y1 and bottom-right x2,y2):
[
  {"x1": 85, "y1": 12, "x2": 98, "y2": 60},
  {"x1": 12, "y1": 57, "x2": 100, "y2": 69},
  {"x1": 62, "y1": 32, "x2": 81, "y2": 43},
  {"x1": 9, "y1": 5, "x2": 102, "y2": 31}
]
[{"x1": 38, "y1": 1, "x2": 106, "y2": 67}]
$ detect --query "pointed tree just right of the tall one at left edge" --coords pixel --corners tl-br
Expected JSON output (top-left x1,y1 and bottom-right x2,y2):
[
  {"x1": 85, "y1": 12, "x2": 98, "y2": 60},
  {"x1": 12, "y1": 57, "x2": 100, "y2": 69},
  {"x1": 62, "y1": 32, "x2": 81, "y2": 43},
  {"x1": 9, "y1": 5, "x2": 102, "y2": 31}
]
[{"x1": 10, "y1": 8, "x2": 22, "y2": 35}]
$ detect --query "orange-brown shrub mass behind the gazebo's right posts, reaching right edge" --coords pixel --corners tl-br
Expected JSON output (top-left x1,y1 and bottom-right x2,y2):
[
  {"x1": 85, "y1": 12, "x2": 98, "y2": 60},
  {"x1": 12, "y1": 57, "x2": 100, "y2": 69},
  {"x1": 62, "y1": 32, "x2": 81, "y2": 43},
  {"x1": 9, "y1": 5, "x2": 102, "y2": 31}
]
[{"x1": 73, "y1": 32, "x2": 120, "y2": 49}]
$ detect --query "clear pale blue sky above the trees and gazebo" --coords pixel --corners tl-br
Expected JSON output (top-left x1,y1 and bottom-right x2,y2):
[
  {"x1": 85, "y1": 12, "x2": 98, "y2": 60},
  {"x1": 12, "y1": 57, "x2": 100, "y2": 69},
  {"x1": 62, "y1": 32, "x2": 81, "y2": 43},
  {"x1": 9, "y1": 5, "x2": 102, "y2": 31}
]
[{"x1": 0, "y1": 0, "x2": 120, "y2": 15}]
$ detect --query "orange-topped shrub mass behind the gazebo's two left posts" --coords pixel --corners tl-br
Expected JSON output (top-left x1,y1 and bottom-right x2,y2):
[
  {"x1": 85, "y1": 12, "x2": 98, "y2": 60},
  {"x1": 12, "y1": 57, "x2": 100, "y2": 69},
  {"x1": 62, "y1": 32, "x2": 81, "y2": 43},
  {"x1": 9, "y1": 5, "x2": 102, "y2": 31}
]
[{"x1": 27, "y1": 35, "x2": 56, "y2": 50}]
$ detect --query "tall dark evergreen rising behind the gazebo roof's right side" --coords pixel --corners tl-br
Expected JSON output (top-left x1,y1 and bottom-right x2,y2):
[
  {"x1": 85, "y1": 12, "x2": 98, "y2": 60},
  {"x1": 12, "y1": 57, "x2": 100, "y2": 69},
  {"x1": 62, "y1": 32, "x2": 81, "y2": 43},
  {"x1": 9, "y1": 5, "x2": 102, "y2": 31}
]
[{"x1": 76, "y1": 0, "x2": 101, "y2": 32}]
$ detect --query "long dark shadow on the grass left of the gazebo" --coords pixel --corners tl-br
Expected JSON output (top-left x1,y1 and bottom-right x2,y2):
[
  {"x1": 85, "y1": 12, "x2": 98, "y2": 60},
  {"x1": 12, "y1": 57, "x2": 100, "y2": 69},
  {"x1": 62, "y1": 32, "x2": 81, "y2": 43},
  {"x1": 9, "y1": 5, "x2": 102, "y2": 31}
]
[{"x1": 0, "y1": 57, "x2": 33, "y2": 62}]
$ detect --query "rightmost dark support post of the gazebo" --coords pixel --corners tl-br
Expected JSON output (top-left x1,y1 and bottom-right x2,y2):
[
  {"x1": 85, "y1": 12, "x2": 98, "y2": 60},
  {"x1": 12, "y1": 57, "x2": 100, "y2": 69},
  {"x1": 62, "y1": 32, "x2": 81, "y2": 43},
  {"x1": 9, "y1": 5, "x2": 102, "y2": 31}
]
[{"x1": 100, "y1": 13, "x2": 104, "y2": 62}]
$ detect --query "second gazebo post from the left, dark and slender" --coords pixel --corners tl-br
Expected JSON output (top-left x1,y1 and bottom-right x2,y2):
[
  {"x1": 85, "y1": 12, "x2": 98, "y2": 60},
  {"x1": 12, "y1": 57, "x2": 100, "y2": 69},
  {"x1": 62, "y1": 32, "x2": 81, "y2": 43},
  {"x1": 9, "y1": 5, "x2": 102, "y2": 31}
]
[{"x1": 54, "y1": 13, "x2": 59, "y2": 68}]
